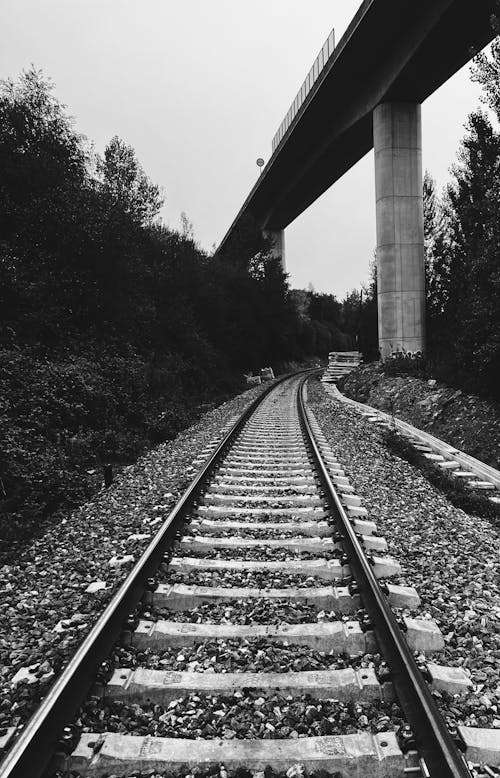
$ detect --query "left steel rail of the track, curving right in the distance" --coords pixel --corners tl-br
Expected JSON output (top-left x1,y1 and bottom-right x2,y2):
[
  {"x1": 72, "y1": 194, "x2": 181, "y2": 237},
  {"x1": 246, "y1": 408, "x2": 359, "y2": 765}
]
[{"x1": 0, "y1": 370, "x2": 318, "y2": 778}]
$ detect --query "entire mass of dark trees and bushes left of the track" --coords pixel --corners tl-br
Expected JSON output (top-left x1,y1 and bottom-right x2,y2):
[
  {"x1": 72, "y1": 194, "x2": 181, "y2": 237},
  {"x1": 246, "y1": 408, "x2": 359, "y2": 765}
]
[{"x1": 0, "y1": 69, "x2": 364, "y2": 551}]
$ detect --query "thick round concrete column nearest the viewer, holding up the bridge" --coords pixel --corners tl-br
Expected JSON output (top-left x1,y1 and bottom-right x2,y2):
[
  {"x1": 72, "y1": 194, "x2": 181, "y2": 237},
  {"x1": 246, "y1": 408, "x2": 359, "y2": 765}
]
[{"x1": 373, "y1": 103, "x2": 425, "y2": 359}]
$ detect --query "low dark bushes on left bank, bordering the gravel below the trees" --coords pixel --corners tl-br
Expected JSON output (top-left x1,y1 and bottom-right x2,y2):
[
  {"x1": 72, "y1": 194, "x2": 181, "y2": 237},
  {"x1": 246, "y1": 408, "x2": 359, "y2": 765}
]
[{"x1": 0, "y1": 341, "x2": 239, "y2": 555}]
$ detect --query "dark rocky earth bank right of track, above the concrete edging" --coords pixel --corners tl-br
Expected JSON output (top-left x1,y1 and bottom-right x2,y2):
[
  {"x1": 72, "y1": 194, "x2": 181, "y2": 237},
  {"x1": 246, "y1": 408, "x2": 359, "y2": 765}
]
[{"x1": 338, "y1": 362, "x2": 500, "y2": 469}]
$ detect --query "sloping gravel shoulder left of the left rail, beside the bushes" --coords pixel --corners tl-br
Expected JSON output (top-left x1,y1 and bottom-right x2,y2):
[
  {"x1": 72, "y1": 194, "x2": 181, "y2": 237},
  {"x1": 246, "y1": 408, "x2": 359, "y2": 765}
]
[{"x1": 0, "y1": 386, "x2": 264, "y2": 735}]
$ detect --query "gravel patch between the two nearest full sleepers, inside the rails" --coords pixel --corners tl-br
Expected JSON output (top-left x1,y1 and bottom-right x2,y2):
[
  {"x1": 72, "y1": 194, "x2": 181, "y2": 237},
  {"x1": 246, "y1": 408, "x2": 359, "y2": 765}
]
[{"x1": 78, "y1": 689, "x2": 404, "y2": 740}]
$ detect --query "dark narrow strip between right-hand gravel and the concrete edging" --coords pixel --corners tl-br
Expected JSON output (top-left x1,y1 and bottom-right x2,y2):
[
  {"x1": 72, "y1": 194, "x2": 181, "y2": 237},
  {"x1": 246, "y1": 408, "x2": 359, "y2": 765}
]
[{"x1": 382, "y1": 429, "x2": 500, "y2": 528}]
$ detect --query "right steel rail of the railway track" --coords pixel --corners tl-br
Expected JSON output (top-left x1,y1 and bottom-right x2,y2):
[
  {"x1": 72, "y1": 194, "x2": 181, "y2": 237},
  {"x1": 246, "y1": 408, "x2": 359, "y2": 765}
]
[{"x1": 297, "y1": 377, "x2": 472, "y2": 778}]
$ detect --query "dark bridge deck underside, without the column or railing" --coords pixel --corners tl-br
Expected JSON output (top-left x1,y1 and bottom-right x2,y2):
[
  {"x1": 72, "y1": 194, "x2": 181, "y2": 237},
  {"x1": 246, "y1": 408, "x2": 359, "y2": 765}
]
[{"x1": 240, "y1": 0, "x2": 495, "y2": 230}]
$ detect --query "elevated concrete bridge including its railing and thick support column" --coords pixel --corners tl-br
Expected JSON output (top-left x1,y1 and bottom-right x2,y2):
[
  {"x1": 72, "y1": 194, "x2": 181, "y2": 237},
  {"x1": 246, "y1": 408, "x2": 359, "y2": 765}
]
[{"x1": 218, "y1": 0, "x2": 496, "y2": 357}]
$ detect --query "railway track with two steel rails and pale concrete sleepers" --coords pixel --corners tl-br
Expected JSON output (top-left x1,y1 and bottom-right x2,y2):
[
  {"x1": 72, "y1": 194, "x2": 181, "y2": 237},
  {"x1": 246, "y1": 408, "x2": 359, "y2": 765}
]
[{"x1": 0, "y1": 376, "x2": 495, "y2": 778}]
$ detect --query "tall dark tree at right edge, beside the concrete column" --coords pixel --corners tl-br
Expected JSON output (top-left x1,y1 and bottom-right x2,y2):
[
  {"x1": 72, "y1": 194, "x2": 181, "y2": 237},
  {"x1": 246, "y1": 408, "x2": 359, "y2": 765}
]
[{"x1": 427, "y1": 111, "x2": 500, "y2": 398}]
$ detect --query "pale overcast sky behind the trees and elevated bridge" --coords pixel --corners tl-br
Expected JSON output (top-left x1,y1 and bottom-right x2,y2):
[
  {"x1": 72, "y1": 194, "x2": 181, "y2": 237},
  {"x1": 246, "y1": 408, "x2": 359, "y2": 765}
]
[{"x1": 0, "y1": 0, "x2": 479, "y2": 297}]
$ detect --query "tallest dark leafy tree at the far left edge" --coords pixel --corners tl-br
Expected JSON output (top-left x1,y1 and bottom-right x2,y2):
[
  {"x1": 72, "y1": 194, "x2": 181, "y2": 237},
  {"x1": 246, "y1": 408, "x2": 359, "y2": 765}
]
[{"x1": 0, "y1": 68, "x2": 99, "y2": 337}]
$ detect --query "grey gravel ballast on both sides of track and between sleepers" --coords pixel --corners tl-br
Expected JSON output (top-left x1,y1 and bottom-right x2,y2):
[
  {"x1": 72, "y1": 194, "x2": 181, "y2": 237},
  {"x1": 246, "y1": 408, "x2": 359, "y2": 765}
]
[{"x1": 0, "y1": 372, "x2": 500, "y2": 778}]
